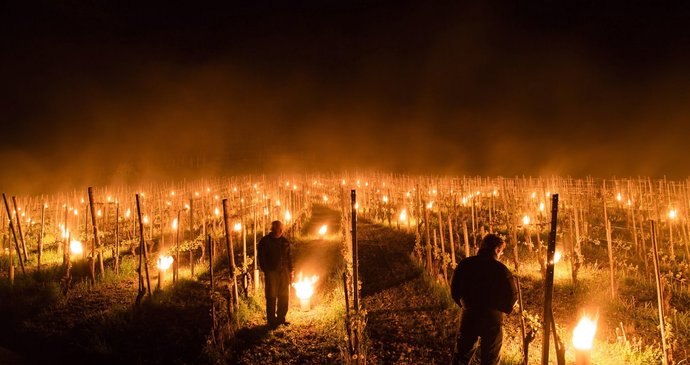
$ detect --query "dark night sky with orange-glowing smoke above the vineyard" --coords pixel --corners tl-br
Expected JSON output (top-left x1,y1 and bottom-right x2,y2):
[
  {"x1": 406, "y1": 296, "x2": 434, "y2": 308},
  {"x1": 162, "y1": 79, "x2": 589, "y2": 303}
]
[{"x1": 0, "y1": 0, "x2": 690, "y2": 194}]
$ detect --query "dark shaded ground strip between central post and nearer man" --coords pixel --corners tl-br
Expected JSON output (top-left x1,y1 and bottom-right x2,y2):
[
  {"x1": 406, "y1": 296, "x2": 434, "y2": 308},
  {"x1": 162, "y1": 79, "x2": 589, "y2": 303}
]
[{"x1": 358, "y1": 222, "x2": 458, "y2": 364}]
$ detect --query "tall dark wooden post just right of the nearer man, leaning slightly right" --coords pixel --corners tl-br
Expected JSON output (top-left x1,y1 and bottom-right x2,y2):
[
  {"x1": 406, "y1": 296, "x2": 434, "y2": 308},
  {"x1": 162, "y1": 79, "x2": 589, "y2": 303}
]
[{"x1": 541, "y1": 194, "x2": 558, "y2": 365}]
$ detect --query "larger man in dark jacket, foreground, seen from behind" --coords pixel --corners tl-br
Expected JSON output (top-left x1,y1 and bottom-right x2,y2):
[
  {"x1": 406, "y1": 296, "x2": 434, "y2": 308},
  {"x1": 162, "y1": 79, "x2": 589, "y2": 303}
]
[{"x1": 450, "y1": 234, "x2": 517, "y2": 365}]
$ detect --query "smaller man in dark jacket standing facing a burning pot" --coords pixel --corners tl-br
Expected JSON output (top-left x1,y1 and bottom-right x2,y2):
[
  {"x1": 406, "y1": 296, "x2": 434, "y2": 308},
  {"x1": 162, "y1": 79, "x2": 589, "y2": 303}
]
[{"x1": 257, "y1": 221, "x2": 293, "y2": 328}]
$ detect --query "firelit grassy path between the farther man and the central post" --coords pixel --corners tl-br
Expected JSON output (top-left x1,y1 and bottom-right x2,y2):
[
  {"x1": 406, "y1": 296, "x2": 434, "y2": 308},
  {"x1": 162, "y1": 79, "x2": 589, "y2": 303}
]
[{"x1": 232, "y1": 206, "x2": 344, "y2": 364}]
